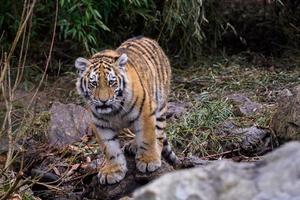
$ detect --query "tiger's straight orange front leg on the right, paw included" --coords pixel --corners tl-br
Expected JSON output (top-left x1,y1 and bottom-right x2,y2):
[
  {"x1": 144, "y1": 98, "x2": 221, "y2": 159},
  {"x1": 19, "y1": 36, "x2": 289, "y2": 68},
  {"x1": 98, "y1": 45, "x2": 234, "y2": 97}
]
[{"x1": 134, "y1": 112, "x2": 162, "y2": 172}]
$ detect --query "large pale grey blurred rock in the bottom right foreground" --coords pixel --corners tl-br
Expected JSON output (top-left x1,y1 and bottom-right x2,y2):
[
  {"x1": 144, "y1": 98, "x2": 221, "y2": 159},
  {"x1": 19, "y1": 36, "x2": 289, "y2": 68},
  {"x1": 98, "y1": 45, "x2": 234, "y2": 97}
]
[{"x1": 133, "y1": 142, "x2": 300, "y2": 200}]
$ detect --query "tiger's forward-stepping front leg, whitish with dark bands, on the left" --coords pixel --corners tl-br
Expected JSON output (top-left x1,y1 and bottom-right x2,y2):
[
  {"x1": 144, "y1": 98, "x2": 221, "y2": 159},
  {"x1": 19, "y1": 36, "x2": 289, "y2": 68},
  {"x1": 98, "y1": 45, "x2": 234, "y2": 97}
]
[{"x1": 96, "y1": 126, "x2": 127, "y2": 184}]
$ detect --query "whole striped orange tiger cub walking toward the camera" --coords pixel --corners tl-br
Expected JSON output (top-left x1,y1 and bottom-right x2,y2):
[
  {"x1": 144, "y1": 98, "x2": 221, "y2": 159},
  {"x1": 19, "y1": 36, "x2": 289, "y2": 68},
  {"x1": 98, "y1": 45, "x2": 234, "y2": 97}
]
[{"x1": 75, "y1": 37, "x2": 177, "y2": 184}]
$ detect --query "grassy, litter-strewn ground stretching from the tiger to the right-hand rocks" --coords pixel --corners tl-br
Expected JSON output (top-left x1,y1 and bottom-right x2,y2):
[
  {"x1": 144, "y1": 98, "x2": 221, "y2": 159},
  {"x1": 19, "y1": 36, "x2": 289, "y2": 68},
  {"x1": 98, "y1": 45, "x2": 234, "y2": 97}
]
[{"x1": 167, "y1": 55, "x2": 300, "y2": 156}]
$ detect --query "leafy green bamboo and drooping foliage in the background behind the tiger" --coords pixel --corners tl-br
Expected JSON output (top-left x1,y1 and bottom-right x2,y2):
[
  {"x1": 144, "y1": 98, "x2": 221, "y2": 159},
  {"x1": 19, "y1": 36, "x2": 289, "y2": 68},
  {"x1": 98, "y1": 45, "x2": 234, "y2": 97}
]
[{"x1": 0, "y1": 0, "x2": 225, "y2": 58}]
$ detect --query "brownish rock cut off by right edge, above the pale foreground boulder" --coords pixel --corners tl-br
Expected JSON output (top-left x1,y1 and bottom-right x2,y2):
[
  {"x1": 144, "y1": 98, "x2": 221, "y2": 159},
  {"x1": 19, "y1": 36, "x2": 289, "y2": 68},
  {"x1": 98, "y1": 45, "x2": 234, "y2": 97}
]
[{"x1": 270, "y1": 85, "x2": 300, "y2": 143}]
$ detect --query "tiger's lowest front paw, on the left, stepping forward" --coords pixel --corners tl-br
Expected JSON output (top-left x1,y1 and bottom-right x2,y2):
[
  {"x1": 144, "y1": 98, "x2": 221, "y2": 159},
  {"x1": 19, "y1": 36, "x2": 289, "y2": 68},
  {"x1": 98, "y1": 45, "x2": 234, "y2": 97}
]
[{"x1": 98, "y1": 163, "x2": 127, "y2": 185}]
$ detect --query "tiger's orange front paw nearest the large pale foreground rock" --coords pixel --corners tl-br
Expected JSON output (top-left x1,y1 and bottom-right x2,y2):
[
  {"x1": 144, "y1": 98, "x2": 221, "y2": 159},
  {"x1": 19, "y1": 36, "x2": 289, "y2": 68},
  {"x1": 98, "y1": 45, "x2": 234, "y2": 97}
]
[{"x1": 136, "y1": 154, "x2": 161, "y2": 173}]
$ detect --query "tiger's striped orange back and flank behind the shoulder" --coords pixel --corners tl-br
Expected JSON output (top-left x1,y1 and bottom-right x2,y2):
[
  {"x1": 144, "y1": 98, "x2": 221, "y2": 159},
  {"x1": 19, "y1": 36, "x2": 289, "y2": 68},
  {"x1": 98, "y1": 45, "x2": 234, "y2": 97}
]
[{"x1": 117, "y1": 37, "x2": 171, "y2": 109}]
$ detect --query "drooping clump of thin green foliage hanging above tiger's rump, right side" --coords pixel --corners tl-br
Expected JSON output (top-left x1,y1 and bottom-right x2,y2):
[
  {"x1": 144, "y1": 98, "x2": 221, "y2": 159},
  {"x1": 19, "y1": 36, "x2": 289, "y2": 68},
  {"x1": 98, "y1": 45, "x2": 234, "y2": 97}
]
[{"x1": 159, "y1": 0, "x2": 208, "y2": 58}]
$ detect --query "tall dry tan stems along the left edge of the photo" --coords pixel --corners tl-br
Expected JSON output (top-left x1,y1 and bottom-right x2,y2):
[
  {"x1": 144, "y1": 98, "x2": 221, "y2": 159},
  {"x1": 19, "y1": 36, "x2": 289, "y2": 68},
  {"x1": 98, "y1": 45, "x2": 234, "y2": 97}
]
[{"x1": 0, "y1": 0, "x2": 58, "y2": 200}]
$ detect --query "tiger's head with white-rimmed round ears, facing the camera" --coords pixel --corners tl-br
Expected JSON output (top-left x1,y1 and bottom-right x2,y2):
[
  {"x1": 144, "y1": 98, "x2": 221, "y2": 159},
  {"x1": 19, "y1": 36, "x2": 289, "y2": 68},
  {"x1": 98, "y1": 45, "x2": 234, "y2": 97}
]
[{"x1": 75, "y1": 50, "x2": 128, "y2": 114}]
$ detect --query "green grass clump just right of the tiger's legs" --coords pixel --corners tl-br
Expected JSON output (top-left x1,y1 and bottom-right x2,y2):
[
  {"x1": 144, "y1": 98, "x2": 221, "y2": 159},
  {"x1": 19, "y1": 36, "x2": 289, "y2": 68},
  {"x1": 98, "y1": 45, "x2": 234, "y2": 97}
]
[{"x1": 167, "y1": 99, "x2": 237, "y2": 156}]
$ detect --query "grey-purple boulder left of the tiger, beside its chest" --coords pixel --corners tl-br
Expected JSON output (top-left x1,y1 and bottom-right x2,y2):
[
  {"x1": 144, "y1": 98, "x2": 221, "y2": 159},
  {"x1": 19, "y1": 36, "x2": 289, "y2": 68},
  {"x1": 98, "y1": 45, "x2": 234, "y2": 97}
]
[{"x1": 48, "y1": 102, "x2": 92, "y2": 146}]
